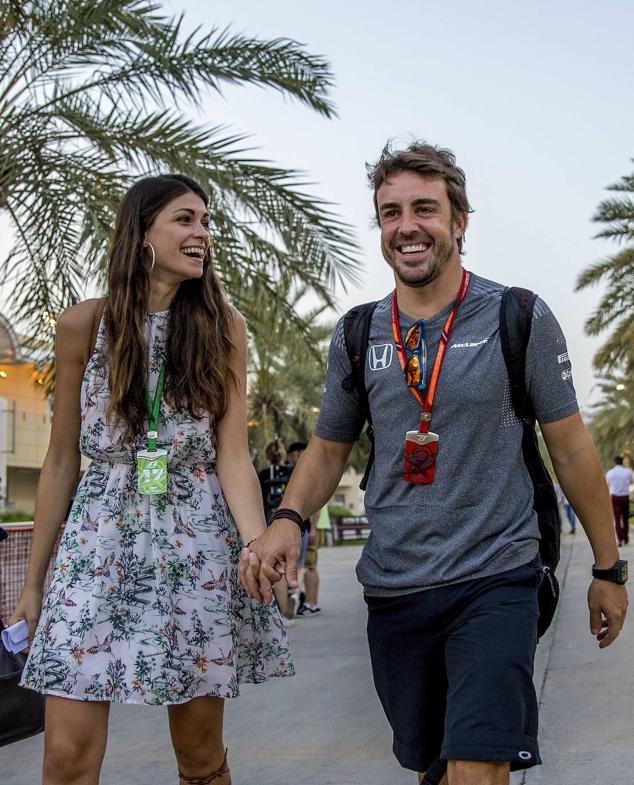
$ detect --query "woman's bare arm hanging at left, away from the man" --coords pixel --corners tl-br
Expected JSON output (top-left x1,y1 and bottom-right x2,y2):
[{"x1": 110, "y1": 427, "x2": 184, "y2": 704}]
[{"x1": 9, "y1": 300, "x2": 98, "y2": 641}]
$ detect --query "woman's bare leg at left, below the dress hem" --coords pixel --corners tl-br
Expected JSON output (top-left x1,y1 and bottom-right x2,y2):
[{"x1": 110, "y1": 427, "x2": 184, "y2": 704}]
[{"x1": 42, "y1": 695, "x2": 110, "y2": 785}]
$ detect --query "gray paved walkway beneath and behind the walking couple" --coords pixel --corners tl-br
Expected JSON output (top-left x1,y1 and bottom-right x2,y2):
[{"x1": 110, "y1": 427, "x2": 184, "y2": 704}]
[{"x1": 0, "y1": 535, "x2": 634, "y2": 785}]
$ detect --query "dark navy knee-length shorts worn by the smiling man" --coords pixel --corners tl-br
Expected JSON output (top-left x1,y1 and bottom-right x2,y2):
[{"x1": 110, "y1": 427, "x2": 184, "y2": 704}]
[{"x1": 365, "y1": 556, "x2": 542, "y2": 771}]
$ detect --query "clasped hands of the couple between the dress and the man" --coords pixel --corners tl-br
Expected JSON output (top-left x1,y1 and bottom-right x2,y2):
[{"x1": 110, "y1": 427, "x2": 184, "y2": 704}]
[{"x1": 238, "y1": 518, "x2": 301, "y2": 605}]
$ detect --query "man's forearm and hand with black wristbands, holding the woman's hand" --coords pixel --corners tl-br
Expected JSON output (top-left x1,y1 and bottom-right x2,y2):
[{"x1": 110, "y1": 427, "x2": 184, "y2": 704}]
[{"x1": 239, "y1": 436, "x2": 354, "y2": 603}]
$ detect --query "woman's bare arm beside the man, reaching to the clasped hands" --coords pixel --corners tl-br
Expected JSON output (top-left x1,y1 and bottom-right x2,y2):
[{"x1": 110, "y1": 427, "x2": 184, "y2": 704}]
[{"x1": 217, "y1": 308, "x2": 266, "y2": 544}]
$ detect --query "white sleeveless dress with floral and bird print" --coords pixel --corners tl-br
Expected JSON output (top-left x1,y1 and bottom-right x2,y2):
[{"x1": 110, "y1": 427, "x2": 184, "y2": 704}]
[{"x1": 22, "y1": 312, "x2": 293, "y2": 705}]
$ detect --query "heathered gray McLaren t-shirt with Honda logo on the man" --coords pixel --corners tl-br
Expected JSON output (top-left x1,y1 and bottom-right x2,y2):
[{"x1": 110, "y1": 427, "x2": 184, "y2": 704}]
[{"x1": 315, "y1": 274, "x2": 578, "y2": 595}]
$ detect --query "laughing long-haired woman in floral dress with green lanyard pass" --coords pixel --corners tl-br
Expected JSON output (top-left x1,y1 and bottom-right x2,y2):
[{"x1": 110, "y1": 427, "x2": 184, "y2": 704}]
[{"x1": 11, "y1": 175, "x2": 292, "y2": 785}]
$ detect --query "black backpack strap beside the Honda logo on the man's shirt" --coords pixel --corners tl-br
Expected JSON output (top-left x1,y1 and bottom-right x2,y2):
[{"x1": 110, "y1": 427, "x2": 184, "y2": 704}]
[{"x1": 341, "y1": 302, "x2": 377, "y2": 490}]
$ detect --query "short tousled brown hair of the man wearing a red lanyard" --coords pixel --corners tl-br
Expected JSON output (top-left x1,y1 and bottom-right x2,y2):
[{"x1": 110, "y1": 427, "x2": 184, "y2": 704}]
[{"x1": 365, "y1": 141, "x2": 473, "y2": 253}]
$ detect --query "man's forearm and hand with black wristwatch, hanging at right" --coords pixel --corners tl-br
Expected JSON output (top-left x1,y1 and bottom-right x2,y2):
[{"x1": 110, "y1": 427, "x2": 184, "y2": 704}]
[{"x1": 540, "y1": 413, "x2": 627, "y2": 649}]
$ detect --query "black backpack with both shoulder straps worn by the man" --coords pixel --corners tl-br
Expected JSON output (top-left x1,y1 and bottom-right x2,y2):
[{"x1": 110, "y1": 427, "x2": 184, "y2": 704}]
[{"x1": 342, "y1": 287, "x2": 560, "y2": 638}]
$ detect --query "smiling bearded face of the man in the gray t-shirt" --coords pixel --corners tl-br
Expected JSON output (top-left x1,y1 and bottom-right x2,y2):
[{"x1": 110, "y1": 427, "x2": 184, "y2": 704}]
[{"x1": 377, "y1": 171, "x2": 467, "y2": 287}]
